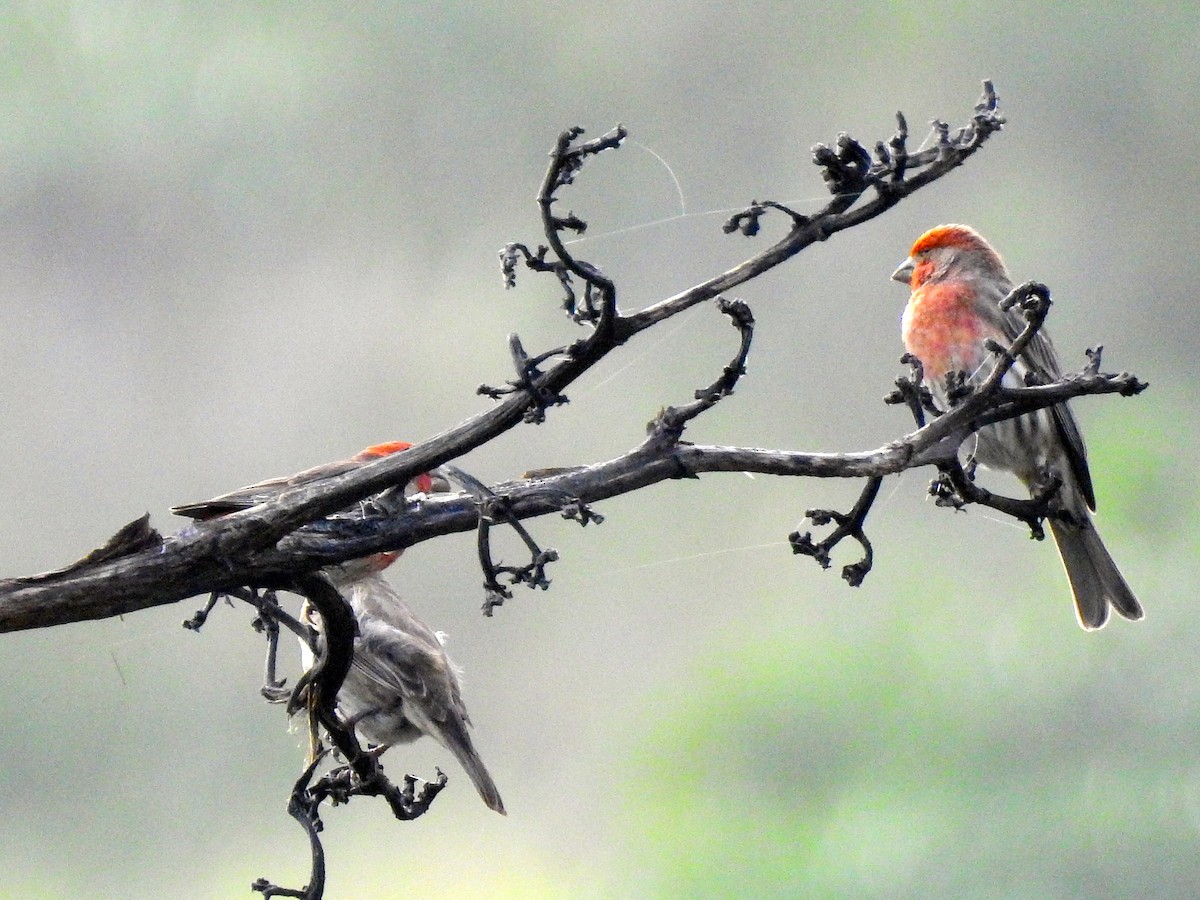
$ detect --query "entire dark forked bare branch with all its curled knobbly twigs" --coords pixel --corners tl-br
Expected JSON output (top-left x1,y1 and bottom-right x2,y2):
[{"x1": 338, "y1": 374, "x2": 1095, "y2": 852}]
[{"x1": 0, "y1": 82, "x2": 1146, "y2": 899}]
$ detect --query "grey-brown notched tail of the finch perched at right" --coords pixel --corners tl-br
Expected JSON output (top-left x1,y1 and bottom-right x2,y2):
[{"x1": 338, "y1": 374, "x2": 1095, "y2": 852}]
[{"x1": 1050, "y1": 514, "x2": 1142, "y2": 631}]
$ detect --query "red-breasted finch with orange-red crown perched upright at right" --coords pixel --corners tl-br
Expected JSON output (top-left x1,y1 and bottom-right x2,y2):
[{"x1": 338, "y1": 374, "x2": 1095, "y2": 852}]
[{"x1": 892, "y1": 224, "x2": 1142, "y2": 629}]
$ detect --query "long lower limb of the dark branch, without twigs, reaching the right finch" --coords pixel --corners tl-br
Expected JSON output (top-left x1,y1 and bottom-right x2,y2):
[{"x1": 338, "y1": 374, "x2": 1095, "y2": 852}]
[{"x1": 0, "y1": 345, "x2": 1145, "y2": 631}]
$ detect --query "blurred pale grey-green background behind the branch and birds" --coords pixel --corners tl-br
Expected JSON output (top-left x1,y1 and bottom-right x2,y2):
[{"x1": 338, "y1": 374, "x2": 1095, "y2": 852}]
[{"x1": 0, "y1": 0, "x2": 1200, "y2": 898}]
